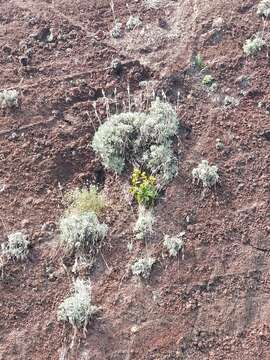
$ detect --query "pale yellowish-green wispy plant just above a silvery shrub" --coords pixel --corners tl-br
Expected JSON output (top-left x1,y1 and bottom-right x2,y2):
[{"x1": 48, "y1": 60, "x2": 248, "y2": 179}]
[{"x1": 64, "y1": 186, "x2": 105, "y2": 214}]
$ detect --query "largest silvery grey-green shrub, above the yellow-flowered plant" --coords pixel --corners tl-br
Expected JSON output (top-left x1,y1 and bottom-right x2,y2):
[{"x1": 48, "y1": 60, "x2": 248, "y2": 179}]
[{"x1": 92, "y1": 98, "x2": 179, "y2": 186}]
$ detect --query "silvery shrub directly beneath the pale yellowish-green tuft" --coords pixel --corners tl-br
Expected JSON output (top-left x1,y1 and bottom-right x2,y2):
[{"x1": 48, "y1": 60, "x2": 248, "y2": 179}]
[{"x1": 59, "y1": 212, "x2": 108, "y2": 254}]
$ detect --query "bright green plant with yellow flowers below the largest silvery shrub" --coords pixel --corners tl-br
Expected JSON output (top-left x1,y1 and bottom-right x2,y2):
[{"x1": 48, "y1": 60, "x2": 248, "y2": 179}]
[{"x1": 130, "y1": 169, "x2": 158, "y2": 207}]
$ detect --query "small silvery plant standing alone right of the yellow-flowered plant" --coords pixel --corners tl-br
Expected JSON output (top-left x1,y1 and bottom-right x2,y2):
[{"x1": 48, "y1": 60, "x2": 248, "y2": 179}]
[{"x1": 192, "y1": 160, "x2": 219, "y2": 188}]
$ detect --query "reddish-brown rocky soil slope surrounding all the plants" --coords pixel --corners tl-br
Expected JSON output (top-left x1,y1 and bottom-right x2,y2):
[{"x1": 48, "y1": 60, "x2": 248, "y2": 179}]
[{"x1": 0, "y1": 0, "x2": 270, "y2": 360}]
